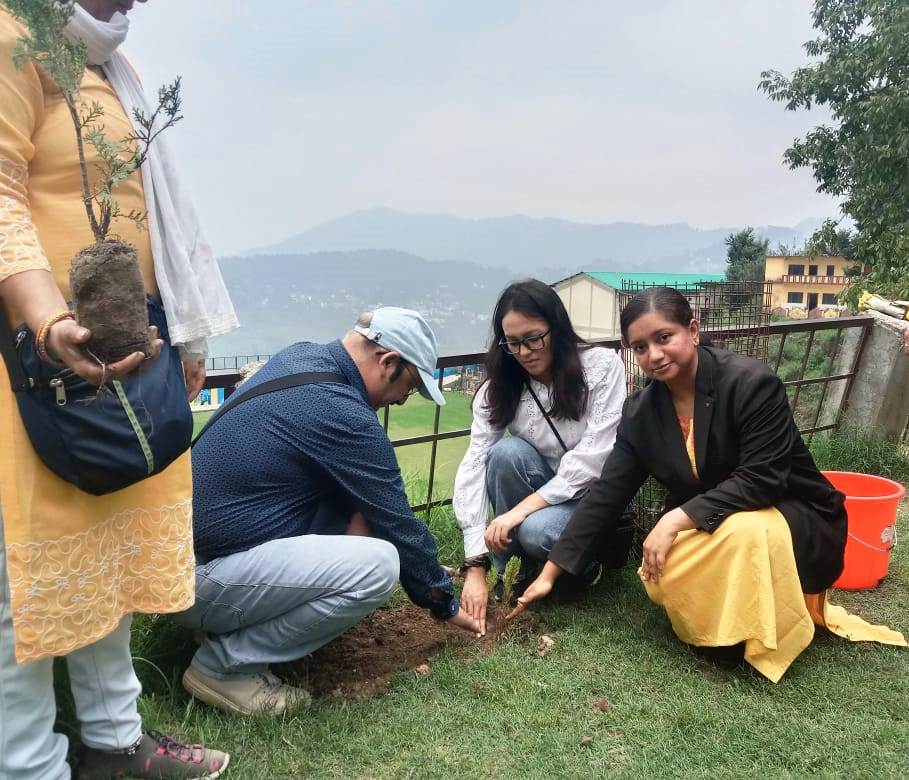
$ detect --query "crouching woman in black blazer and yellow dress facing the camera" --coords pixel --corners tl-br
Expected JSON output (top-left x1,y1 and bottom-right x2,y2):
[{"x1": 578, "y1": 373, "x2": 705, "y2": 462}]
[{"x1": 512, "y1": 287, "x2": 900, "y2": 682}]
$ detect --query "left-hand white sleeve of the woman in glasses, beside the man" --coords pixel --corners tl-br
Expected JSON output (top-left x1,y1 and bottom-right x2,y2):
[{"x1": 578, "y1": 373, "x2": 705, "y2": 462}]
[{"x1": 452, "y1": 384, "x2": 505, "y2": 558}]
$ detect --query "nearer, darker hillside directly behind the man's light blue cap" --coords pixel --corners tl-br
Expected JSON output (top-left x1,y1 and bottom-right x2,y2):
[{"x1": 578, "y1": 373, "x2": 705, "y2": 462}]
[{"x1": 211, "y1": 251, "x2": 517, "y2": 356}]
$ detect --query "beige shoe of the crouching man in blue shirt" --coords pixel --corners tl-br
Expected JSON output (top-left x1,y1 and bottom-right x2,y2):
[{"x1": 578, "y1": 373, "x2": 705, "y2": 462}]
[{"x1": 183, "y1": 666, "x2": 312, "y2": 715}]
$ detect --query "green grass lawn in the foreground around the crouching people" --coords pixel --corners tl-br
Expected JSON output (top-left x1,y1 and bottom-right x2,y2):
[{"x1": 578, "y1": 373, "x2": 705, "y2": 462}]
[{"x1": 110, "y1": 502, "x2": 909, "y2": 780}]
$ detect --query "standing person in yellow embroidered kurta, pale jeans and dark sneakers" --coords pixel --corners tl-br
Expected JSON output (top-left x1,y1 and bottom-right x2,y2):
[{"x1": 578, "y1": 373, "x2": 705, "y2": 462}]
[{"x1": 0, "y1": 0, "x2": 228, "y2": 780}]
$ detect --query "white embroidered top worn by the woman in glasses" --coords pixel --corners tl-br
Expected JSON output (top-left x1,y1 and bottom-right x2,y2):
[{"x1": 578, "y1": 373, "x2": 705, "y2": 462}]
[{"x1": 453, "y1": 347, "x2": 625, "y2": 558}]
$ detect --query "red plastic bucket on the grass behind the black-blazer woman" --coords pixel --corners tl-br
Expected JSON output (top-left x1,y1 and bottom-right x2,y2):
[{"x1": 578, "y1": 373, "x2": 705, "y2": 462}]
[{"x1": 822, "y1": 471, "x2": 906, "y2": 590}]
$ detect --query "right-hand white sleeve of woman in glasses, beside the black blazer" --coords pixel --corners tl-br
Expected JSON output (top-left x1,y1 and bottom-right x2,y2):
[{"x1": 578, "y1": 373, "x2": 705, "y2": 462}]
[{"x1": 537, "y1": 350, "x2": 626, "y2": 505}]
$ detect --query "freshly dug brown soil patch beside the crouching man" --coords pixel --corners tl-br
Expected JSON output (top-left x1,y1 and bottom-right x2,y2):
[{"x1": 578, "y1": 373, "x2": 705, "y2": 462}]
[{"x1": 279, "y1": 604, "x2": 529, "y2": 699}]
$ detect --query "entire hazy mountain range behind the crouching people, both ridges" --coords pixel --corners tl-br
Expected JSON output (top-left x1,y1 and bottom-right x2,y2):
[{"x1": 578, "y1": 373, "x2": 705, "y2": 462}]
[{"x1": 210, "y1": 208, "x2": 820, "y2": 355}]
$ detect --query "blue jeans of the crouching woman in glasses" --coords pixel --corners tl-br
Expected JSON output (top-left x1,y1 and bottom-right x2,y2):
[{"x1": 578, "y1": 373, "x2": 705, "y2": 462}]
[{"x1": 486, "y1": 436, "x2": 579, "y2": 579}]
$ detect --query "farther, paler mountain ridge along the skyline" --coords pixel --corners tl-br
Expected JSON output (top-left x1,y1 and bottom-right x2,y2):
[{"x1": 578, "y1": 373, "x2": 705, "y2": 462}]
[{"x1": 244, "y1": 208, "x2": 820, "y2": 273}]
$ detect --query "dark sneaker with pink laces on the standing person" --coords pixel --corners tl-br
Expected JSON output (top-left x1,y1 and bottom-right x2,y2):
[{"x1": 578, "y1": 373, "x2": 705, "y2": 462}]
[{"x1": 74, "y1": 731, "x2": 230, "y2": 780}]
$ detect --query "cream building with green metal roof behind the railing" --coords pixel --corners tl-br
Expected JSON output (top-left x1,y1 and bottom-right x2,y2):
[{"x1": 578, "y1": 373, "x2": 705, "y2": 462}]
[{"x1": 552, "y1": 271, "x2": 725, "y2": 340}]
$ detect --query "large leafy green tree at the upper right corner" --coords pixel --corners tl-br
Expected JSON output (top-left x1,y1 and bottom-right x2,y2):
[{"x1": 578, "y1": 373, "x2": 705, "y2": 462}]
[{"x1": 760, "y1": 0, "x2": 909, "y2": 305}]
